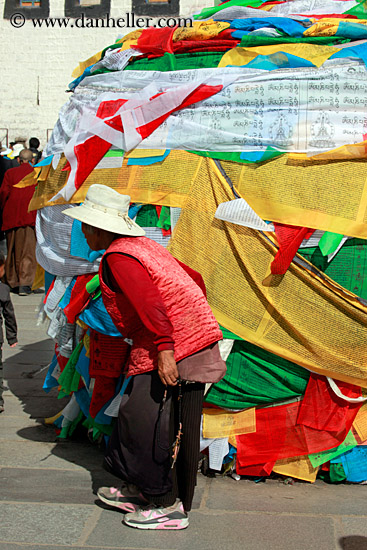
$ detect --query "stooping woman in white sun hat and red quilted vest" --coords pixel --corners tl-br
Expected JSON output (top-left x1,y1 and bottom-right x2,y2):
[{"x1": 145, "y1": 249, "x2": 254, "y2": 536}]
[{"x1": 64, "y1": 185, "x2": 225, "y2": 529}]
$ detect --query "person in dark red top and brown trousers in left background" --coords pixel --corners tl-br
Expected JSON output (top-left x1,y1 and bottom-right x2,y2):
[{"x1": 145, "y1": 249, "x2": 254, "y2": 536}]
[{"x1": 0, "y1": 149, "x2": 37, "y2": 296}]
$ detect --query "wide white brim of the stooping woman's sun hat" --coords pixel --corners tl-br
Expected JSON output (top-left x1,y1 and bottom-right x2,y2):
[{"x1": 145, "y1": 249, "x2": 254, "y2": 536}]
[{"x1": 62, "y1": 204, "x2": 145, "y2": 237}]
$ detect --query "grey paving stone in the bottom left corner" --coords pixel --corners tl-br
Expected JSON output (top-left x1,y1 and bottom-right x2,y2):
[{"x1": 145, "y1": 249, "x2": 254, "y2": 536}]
[{"x1": 0, "y1": 502, "x2": 94, "y2": 548}]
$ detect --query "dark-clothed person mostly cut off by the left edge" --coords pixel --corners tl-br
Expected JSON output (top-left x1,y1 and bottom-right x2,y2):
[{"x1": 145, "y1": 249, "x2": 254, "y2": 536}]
[{"x1": 0, "y1": 253, "x2": 17, "y2": 413}]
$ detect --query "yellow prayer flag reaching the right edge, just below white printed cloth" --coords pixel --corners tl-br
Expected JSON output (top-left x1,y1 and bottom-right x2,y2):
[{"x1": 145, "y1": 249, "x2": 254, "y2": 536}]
[{"x1": 230, "y1": 155, "x2": 367, "y2": 239}]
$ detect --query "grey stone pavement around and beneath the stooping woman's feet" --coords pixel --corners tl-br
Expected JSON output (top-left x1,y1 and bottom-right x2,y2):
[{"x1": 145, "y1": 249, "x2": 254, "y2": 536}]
[{"x1": 0, "y1": 295, "x2": 367, "y2": 550}]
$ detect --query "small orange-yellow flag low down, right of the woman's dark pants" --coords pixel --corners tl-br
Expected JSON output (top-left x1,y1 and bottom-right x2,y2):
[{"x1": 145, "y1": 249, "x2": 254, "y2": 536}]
[{"x1": 203, "y1": 408, "x2": 256, "y2": 439}]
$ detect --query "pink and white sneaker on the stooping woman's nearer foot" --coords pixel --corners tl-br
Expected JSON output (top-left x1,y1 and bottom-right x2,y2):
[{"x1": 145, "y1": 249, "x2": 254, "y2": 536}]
[{"x1": 124, "y1": 501, "x2": 189, "y2": 529}]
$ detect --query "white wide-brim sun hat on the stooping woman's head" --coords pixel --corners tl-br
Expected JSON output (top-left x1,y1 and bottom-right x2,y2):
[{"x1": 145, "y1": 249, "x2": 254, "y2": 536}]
[{"x1": 63, "y1": 183, "x2": 145, "y2": 237}]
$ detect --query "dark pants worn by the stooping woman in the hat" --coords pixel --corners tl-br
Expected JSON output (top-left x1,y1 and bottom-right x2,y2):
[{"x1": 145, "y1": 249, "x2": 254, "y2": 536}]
[{"x1": 105, "y1": 371, "x2": 204, "y2": 511}]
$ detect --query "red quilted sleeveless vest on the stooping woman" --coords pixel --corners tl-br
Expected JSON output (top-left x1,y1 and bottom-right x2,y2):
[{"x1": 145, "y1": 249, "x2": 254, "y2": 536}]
[{"x1": 99, "y1": 237, "x2": 223, "y2": 375}]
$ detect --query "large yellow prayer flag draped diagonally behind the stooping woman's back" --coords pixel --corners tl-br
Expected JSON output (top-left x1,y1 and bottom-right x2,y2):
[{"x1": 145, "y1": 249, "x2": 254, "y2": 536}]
[{"x1": 169, "y1": 158, "x2": 367, "y2": 387}]
